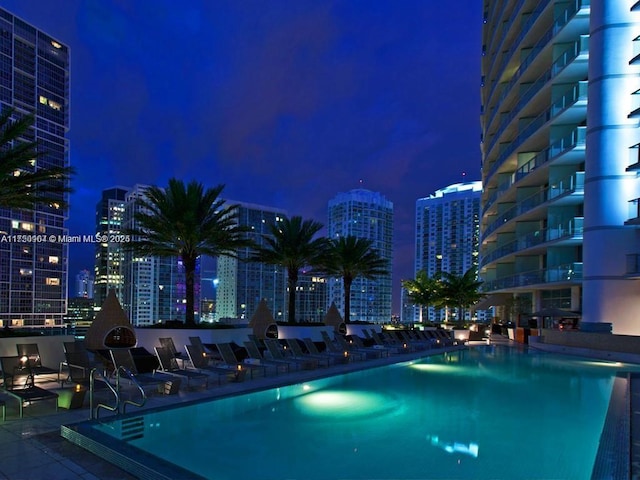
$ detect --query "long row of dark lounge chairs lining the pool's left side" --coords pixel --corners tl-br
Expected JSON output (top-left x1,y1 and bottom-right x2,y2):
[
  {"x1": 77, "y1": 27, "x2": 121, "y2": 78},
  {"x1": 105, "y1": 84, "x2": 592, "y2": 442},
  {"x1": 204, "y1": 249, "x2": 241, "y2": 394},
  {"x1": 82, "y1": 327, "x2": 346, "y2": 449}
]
[{"x1": 0, "y1": 329, "x2": 453, "y2": 416}]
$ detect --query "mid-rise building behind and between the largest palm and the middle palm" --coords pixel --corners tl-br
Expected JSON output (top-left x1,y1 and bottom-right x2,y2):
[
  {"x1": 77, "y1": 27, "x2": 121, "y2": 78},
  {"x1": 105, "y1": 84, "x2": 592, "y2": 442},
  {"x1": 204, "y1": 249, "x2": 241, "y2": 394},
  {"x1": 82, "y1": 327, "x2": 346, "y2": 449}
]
[{"x1": 215, "y1": 202, "x2": 286, "y2": 322}]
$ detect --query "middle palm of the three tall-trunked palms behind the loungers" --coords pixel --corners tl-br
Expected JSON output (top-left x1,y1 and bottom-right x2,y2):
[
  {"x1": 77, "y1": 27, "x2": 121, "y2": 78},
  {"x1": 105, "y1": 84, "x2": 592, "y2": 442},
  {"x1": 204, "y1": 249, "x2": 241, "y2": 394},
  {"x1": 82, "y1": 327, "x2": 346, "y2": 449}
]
[{"x1": 250, "y1": 216, "x2": 327, "y2": 323}]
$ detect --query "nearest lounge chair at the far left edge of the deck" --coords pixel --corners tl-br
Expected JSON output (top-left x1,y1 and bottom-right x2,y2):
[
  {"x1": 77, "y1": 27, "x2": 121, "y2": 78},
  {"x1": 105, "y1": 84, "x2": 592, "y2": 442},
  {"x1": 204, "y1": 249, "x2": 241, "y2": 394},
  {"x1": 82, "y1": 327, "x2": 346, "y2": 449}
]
[{"x1": 0, "y1": 355, "x2": 58, "y2": 418}]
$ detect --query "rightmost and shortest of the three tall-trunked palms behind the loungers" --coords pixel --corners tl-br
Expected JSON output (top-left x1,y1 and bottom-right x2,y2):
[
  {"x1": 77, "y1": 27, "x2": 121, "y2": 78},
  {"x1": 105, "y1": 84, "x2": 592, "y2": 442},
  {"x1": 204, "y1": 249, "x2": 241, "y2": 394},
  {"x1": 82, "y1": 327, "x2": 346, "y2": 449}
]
[{"x1": 322, "y1": 235, "x2": 389, "y2": 323}]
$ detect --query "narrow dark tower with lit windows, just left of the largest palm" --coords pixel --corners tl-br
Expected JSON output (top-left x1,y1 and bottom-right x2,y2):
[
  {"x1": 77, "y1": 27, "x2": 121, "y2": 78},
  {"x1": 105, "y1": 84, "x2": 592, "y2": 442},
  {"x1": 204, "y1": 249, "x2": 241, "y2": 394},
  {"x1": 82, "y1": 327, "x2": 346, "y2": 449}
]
[{"x1": 94, "y1": 187, "x2": 129, "y2": 307}]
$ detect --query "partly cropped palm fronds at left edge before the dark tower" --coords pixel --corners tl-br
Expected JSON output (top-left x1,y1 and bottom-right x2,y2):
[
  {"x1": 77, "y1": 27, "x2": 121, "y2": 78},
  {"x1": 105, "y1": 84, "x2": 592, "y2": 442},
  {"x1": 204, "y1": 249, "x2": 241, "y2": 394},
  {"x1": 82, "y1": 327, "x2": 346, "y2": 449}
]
[{"x1": 0, "y1": 109, "x2": 75, "y2": 210}]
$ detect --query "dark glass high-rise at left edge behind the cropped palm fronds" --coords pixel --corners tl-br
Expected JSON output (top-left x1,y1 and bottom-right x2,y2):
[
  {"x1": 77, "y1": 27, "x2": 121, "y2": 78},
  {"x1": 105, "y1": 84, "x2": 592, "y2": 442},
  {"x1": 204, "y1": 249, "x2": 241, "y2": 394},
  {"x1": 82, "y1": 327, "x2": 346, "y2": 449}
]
[{"x1": 0, "y1": 8, "x2": 69, "y2": 326}]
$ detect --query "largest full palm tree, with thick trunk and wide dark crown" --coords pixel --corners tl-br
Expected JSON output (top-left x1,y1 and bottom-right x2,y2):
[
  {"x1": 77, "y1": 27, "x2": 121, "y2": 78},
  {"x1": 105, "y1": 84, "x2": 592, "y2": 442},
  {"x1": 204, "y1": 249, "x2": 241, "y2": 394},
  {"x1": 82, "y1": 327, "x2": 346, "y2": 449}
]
[{"x1": 125, "y1": 178, "x2": 252, "y2": 326}]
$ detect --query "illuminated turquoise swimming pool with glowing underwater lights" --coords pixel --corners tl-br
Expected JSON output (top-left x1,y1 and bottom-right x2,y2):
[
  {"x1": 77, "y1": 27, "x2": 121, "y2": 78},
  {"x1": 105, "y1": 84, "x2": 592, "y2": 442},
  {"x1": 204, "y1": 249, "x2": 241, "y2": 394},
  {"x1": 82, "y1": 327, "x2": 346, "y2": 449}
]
[{"x1": 60, "y1": 346, "x2": 638, "y2": 480}]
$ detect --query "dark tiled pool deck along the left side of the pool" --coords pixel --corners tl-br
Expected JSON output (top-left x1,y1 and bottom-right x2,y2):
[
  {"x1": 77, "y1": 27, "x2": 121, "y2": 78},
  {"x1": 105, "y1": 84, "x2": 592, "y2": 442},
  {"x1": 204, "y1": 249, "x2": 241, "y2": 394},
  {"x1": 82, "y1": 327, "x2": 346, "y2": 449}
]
[{"x1": 0, "y1": 341, "x2": 464, "y2": 480}]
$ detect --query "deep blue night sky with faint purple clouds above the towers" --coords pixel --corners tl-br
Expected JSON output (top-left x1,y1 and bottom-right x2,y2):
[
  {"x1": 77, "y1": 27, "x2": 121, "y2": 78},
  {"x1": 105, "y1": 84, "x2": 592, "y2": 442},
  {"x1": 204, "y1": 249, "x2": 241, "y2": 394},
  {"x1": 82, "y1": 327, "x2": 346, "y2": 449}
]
[{"x1": 0, "y1": 0, "x2": 482, "y2": 313}]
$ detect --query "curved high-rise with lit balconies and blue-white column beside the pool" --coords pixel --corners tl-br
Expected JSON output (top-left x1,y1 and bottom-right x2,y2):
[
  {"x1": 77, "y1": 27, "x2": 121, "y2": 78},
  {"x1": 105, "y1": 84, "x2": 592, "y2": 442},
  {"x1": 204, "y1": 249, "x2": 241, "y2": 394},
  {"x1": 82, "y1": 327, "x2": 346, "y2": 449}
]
[{"x1": 480, "y1": 0, "x2": 640, "y2": 334}]
